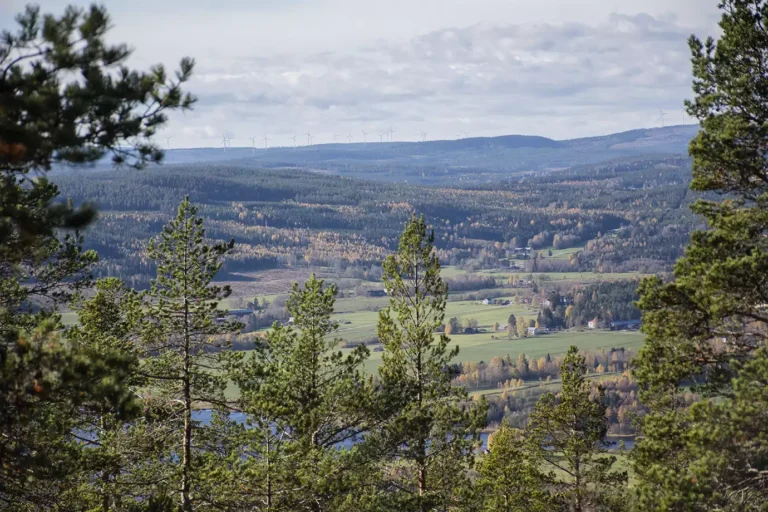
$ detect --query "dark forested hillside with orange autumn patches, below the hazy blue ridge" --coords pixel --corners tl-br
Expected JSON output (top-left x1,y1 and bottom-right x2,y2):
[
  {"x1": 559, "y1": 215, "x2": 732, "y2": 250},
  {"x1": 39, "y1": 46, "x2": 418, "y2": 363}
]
[{"x1": 56, "y1": 152, "x2": 696, "y2": 284}]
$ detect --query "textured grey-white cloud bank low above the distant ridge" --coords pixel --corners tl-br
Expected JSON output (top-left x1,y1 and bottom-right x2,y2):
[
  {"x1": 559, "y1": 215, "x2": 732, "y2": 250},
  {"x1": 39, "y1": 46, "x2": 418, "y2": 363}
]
[{"x1": 171, "y1": 14, "x2": 712, "y2": 144}]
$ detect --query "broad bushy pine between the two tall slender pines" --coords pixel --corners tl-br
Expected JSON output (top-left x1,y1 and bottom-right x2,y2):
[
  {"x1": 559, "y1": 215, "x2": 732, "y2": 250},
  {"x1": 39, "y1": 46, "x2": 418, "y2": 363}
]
[{"x1": 222, "y1": 274, "x2": 379, "y2": 511}]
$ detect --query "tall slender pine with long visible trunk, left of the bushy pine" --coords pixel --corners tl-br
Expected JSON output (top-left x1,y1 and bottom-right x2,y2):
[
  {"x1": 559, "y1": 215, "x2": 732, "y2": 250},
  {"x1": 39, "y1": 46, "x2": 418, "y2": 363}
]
[{"x1": 142, "y1": 198, "x2": 239, "y2": 512}]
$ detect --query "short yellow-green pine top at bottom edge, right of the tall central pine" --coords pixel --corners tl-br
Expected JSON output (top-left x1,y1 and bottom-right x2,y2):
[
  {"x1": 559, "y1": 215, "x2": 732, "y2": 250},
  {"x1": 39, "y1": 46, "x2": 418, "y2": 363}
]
[{"x1": 475, "y1": 422, "x2": 554, "y2": 512}]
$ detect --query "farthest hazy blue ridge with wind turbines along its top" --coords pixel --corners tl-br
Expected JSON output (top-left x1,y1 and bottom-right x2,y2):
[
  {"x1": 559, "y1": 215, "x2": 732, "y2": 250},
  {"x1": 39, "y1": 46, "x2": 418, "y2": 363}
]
[{"x1": 57, "y1": 125, "x2": 698, "y2": 186}]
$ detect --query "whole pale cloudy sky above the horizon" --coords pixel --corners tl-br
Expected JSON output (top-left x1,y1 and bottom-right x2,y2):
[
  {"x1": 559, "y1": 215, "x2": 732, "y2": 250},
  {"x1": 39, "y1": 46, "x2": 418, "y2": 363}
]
[{"x1": 0, "y1": 0, "x2": 719, "y2": 147}]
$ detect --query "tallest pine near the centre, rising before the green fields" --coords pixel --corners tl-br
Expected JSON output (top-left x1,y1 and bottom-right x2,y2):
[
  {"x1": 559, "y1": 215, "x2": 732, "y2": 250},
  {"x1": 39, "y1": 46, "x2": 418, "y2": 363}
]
[{"x1": 378, "y1": 217, "x2": 486, "y2": 512}]
